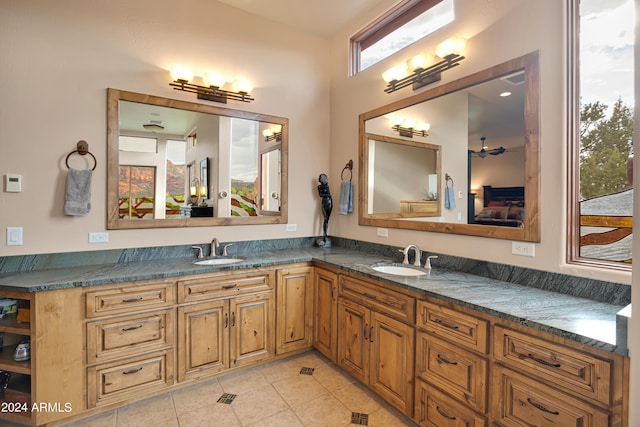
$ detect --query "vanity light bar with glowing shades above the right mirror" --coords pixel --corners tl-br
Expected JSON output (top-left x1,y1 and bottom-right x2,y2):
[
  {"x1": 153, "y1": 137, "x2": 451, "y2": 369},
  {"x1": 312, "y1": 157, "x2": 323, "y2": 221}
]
[{"x1": 382, "y1": 37, "x2": 466, "y2": 93}]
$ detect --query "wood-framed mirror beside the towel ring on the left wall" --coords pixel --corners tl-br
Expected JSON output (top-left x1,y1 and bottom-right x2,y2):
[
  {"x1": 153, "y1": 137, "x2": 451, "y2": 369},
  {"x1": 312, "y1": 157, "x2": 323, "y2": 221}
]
[{"x1": 107, "y1": 89, "x2": 288, "y2": 230}]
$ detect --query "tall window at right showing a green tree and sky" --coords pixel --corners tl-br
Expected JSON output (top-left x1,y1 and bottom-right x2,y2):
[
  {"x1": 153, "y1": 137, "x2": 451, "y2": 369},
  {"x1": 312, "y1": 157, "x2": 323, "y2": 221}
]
[{"x1": 568, "y1": 0, "x2": 634, "y2": 269}]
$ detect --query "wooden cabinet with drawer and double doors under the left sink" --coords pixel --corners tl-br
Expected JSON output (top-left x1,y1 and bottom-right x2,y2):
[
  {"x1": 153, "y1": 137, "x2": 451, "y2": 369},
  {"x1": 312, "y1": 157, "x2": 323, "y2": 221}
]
[{"x1": 178, "y1": 271, "x2": 275, "y2": 382}]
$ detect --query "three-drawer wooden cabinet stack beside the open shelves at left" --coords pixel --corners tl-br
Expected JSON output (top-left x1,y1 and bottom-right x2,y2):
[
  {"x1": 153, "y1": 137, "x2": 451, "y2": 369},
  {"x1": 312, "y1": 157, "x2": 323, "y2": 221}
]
[{"x1": 85, "y1": 280, "x2": 175, "y2": 408}]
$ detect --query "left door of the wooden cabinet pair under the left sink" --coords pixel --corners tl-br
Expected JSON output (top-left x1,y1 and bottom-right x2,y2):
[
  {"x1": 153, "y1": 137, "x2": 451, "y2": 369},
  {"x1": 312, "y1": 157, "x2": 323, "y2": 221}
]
[{"x1": 178, "y1": 300, "x2": 230, "y2": 381}]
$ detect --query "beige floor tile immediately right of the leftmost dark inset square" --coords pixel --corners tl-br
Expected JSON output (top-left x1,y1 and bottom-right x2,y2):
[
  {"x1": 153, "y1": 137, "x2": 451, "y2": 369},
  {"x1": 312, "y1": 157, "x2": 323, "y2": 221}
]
[{"x1": 231, "y1": 384, "x2": 289, "y2": 425}]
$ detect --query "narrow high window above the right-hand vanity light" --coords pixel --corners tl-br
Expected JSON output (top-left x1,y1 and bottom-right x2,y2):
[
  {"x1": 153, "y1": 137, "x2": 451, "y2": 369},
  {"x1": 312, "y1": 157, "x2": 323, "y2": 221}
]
[{"x1": 351, "y1": 0, "x2": 454, "y2": 75}]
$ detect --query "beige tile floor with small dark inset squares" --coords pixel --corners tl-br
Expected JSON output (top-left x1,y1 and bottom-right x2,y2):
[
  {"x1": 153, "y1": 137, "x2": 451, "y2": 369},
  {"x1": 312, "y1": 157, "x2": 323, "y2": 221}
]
[{"x1": 36, "y1": 350, "x2": 415, "y2": 427}]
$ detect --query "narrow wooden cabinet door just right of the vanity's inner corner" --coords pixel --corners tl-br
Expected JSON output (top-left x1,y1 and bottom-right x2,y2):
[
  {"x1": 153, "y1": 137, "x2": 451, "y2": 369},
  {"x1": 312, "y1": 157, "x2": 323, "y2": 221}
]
[{"x1": 313, "y1": 269, "x2": 338, "y2": 362}]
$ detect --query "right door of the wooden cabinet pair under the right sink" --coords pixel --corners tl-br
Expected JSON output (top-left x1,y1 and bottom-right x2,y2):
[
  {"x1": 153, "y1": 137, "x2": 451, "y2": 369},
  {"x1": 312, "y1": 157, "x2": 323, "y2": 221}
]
[{"x1": 369, "y1": 311, "x2": 415, "y2": 416}]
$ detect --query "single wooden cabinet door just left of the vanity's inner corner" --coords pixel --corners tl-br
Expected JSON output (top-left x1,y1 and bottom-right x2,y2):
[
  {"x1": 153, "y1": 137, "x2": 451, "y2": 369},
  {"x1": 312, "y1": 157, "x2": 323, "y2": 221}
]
[{"x1": 276, "y1": 266, "x2": 313, "y2": 354}]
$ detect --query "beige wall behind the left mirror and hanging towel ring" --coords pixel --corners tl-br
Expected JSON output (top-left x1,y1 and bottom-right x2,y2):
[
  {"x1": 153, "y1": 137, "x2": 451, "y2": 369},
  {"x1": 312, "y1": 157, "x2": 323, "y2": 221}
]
[{"x1": 0, "y1": 0, "x2": 330, "y2": 256}]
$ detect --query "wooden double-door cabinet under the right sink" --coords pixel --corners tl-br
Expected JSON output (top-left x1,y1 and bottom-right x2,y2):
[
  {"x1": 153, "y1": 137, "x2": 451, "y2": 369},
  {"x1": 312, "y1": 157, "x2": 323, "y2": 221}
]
[{"x1": 337, "y1": 277, "x2": 415, "y2": 416}]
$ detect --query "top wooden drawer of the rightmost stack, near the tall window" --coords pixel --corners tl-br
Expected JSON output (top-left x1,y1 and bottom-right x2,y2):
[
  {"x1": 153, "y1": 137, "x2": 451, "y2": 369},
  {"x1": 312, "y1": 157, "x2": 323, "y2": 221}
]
[{"x1": 494, "y1": 325, "x2": 612, "y2": 405}]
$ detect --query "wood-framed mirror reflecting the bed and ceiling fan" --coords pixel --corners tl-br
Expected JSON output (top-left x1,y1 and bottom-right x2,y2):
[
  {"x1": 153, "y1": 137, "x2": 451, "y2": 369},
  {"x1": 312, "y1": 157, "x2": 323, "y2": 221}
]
[{"x1": 358, "y1": 52, "x2": 540, "y2": 242}]
